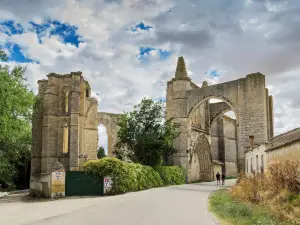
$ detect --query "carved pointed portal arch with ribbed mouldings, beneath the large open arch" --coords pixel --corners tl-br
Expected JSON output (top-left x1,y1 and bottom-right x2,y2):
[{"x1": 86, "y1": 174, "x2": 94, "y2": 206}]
[{"x1": 190, "y1": 135, "x2": 213, "y2": 181}]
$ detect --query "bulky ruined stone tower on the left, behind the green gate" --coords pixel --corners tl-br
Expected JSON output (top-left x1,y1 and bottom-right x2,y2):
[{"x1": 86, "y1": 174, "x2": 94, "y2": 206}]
[{"x1": 30, "y1": 72, "x2": 98, "y2": 196}]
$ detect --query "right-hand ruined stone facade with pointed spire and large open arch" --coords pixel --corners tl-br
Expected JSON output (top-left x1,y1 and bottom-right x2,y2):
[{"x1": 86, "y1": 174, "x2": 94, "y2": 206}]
[{"x1": 166, "y1": 57, "x2": 273, "y2": 181}]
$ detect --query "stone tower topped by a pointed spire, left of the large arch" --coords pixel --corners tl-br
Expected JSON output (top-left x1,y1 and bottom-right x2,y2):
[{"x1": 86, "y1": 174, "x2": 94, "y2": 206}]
[{"x1": 166, "y1": 56, "x2": 191, "y2": 170}]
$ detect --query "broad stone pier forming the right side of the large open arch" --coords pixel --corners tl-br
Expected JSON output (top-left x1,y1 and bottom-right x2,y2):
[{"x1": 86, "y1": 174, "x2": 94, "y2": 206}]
[{"x1": 237, "y1": 73, "x2": 268, "y2": 171}]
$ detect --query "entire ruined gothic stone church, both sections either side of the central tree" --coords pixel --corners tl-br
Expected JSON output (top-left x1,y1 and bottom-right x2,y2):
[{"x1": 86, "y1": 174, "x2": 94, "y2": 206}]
[{"x1": 30, "y1": 57, "x2": 273, "y2": 195}]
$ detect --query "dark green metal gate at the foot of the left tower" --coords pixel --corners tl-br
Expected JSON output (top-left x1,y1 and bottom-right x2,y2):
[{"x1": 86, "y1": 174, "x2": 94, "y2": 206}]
[{"x1": 66, "y1": 171, "x2": 103, "y2": 196}]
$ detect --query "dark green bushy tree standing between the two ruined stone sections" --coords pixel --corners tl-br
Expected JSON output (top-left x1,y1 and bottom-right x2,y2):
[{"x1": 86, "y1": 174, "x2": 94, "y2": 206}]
[{"x1": 115, "y1": 98, "x2": 178, "y2": 166}]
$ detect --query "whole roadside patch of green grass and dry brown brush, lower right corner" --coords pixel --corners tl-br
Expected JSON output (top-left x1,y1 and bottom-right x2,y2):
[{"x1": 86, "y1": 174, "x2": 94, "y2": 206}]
[{"x1": 210, "y1": 160, "x2": 300, "y2": 224}]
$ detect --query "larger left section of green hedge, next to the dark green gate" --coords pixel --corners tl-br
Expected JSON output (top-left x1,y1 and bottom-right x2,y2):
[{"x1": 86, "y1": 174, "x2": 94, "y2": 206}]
[{"x1": 84, "y1": 158, "x2": 163, "y2": 194}]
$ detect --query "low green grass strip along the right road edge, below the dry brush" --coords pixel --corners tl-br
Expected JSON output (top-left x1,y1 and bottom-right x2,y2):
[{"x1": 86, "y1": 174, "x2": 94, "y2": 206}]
[{"x1": 209, "y1": 190, "x2": 296, "y2": 225}]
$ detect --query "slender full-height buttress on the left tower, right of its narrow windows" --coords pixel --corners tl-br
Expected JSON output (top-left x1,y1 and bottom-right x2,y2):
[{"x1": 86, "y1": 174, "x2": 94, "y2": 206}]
[{"x1": 69, "y1": 72, "x2": 81, "y2": 170}]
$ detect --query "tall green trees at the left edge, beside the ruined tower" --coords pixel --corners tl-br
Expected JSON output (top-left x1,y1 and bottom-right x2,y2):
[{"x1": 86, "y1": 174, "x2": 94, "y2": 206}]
[{"x1": 0, "y1": 51, "x2": 34, "y2": 188}]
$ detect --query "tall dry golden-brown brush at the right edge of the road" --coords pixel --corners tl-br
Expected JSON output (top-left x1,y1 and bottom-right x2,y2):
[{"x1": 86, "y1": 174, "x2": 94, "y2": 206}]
[{"x1": 230, "y1": 160, "x2": 300, "y2": 224}]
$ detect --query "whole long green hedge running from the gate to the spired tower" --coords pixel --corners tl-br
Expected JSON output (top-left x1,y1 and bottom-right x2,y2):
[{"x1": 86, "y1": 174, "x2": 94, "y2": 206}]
[{"x1": 84, "y1": 157, "x2": 185, "y2": 194}]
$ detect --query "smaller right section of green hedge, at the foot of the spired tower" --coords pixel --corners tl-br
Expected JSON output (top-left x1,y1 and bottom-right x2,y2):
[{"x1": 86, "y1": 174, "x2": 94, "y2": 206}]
[{"x1": 156, "y1": 166, "x2": 185, "y2": 185}]
